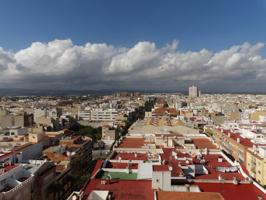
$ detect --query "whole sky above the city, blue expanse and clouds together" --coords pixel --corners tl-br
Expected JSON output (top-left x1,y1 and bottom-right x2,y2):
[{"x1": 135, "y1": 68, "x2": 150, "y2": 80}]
[{"x1": 0, "y1": 0, "x2": 266, "y2": 92}]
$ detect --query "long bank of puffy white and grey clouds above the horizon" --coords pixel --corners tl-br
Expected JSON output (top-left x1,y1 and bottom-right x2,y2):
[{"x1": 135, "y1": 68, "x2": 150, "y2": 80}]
[{"x1": 0, "y1": 39, "x2": 266, "y2": 91}]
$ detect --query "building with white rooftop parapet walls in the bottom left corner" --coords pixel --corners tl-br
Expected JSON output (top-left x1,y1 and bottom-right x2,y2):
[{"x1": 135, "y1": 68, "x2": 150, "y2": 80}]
[{"x1": 0, "y1": 160, "x2": 54, "y2": 200}]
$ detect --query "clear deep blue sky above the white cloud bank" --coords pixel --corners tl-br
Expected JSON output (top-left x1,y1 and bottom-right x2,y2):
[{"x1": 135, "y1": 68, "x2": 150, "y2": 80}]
[{"x1": 0, "y1": 0, "x2": 266, "y2": 51}]
